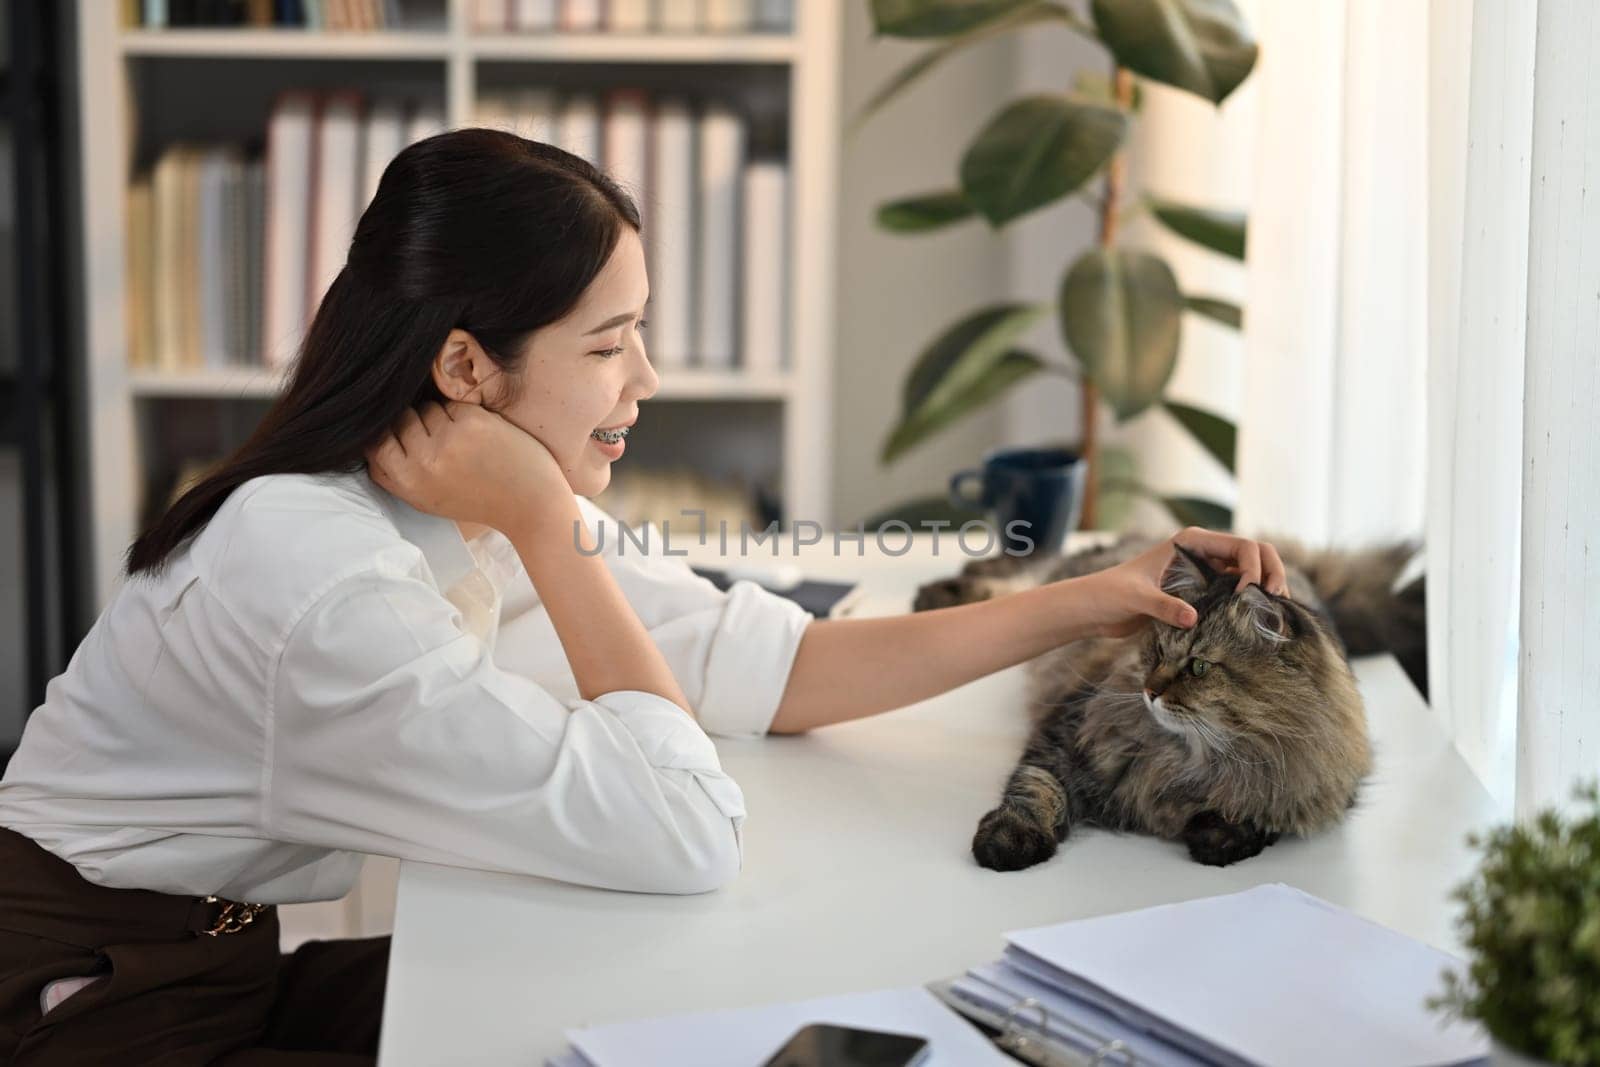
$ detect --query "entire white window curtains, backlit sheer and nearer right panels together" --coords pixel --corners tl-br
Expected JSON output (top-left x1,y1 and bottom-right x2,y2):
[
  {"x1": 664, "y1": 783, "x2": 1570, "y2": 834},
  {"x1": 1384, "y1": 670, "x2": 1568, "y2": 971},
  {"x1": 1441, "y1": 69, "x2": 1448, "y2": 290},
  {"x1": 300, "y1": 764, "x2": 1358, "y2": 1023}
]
[{"x1": 1238, "y1": 0, "x2": 1600, "y2": 814}]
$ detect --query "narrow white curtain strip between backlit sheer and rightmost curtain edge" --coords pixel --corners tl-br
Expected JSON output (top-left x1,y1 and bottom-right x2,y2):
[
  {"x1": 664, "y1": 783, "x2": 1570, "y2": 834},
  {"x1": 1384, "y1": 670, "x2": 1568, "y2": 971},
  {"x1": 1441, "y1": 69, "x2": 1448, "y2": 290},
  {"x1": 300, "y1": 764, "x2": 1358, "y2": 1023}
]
[{"x1": 1427, "y1": 0, "x2": 1536, "y2": 803}]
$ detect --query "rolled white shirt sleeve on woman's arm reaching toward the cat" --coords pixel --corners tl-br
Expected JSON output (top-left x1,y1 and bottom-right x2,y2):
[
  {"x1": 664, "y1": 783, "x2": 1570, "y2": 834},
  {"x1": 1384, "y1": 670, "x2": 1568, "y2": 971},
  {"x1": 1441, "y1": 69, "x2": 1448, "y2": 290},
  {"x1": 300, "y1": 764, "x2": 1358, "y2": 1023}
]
[{"x1": 498, "y1": 496, "x2": 814, "y2": 737}]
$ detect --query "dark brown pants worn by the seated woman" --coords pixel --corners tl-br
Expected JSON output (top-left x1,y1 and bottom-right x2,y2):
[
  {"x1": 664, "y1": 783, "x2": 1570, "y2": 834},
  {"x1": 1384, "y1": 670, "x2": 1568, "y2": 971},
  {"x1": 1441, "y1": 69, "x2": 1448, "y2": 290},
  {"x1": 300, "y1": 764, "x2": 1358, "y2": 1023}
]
[{"x1": 0, "y1": 827, "x2": 389, "y2": 1067}]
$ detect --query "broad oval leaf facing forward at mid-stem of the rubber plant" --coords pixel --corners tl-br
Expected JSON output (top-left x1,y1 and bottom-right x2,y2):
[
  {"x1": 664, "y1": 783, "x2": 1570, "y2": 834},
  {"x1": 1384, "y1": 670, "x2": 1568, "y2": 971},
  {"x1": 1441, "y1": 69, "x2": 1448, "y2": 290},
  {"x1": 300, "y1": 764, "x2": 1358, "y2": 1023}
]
[{"x1": 1059, "y1": 248, "x2": 1184, "y2": 419}]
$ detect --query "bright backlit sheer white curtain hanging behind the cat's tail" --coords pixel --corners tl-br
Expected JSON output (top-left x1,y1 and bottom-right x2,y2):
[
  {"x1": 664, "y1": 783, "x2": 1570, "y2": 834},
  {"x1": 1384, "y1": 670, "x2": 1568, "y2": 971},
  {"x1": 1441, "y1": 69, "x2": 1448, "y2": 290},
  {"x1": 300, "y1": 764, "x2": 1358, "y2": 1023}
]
[{"x1": 1237, "y1": 0, "x2": 1427, "y2": 544}]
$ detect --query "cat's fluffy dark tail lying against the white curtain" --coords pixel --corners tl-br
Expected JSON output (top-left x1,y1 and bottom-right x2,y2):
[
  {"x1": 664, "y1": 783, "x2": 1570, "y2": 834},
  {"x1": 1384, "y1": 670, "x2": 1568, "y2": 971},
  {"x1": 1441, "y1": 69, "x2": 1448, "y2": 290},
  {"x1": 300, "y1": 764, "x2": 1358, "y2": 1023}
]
[{"x1": 1266, "y1": 536, "x2": 1427, "y2": 697}]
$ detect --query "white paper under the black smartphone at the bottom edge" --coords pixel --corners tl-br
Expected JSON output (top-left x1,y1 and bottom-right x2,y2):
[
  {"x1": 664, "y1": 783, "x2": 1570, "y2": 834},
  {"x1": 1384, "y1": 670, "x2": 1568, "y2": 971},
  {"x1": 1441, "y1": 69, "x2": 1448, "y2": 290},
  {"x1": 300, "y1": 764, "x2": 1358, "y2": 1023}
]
[{"x1": 549, "y1": 989, "x2": 1016, "y2": 1067}]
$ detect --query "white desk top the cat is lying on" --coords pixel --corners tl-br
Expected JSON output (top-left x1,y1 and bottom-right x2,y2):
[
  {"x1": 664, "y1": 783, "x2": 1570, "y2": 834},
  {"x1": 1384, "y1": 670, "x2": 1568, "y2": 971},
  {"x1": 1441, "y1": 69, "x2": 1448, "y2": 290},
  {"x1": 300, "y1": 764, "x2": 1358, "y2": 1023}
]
[{"x1": 381, "y1": 537, "x2": 1498, "y2": 1067}]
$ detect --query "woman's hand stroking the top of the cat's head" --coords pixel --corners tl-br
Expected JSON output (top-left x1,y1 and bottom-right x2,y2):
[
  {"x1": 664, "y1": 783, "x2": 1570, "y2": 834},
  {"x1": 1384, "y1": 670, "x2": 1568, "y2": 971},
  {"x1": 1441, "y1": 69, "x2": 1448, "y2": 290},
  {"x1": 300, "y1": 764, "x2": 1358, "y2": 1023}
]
[{"x1": 1074, "y1": 526, "x2": 1288, "y2": 637}]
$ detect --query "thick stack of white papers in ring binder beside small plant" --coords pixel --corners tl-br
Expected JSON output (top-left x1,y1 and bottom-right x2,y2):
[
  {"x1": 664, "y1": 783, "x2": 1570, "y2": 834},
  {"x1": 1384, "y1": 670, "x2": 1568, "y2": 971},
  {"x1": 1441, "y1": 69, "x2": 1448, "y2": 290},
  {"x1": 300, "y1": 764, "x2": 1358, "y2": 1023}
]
[{"x1": 952, "y1": 885, "x2": 1488, "y2": 1067}]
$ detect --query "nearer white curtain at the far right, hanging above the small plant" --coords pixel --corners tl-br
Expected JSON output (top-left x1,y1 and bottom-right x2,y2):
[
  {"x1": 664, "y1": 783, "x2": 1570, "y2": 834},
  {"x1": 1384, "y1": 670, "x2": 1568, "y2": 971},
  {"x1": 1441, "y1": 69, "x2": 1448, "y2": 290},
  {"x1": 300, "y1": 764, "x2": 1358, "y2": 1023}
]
[{"x1": 1427, "y1": 0, "x2": 1600, "y2": 816}]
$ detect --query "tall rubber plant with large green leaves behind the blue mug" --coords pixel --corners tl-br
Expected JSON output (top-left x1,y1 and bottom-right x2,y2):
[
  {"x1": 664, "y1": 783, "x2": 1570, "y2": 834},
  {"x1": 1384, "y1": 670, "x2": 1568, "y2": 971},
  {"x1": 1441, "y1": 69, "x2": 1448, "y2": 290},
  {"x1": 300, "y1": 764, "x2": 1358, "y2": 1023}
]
[{"x1": 856, "y1": 0, "x2": 1256, "y2": 528}]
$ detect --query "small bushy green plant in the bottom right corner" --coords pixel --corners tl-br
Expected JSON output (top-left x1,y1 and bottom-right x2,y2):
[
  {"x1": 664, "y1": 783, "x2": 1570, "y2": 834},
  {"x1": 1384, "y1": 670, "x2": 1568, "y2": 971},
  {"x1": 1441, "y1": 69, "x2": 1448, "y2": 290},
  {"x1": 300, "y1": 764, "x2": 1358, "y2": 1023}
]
[{"x1": 1430, "y1": 784, "x2": 1600, "y2": 1067}]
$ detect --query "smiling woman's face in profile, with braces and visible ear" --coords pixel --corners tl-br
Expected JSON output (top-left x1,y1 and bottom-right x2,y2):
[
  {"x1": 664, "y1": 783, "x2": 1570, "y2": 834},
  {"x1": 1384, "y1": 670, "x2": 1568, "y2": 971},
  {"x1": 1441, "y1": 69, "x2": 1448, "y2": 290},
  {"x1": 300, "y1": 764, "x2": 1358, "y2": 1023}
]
[{"x1": 435, "y1": 227, "x2": 661, "y2": 496}]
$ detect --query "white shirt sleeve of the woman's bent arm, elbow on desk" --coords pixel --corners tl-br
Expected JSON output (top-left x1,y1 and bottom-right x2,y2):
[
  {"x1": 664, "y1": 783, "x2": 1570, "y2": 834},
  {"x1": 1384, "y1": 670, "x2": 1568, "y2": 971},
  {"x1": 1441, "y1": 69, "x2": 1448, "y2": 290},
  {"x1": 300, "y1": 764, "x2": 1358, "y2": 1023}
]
[{"x1": 262, "y1": 573, "x2": 746, "y2": 893}]
